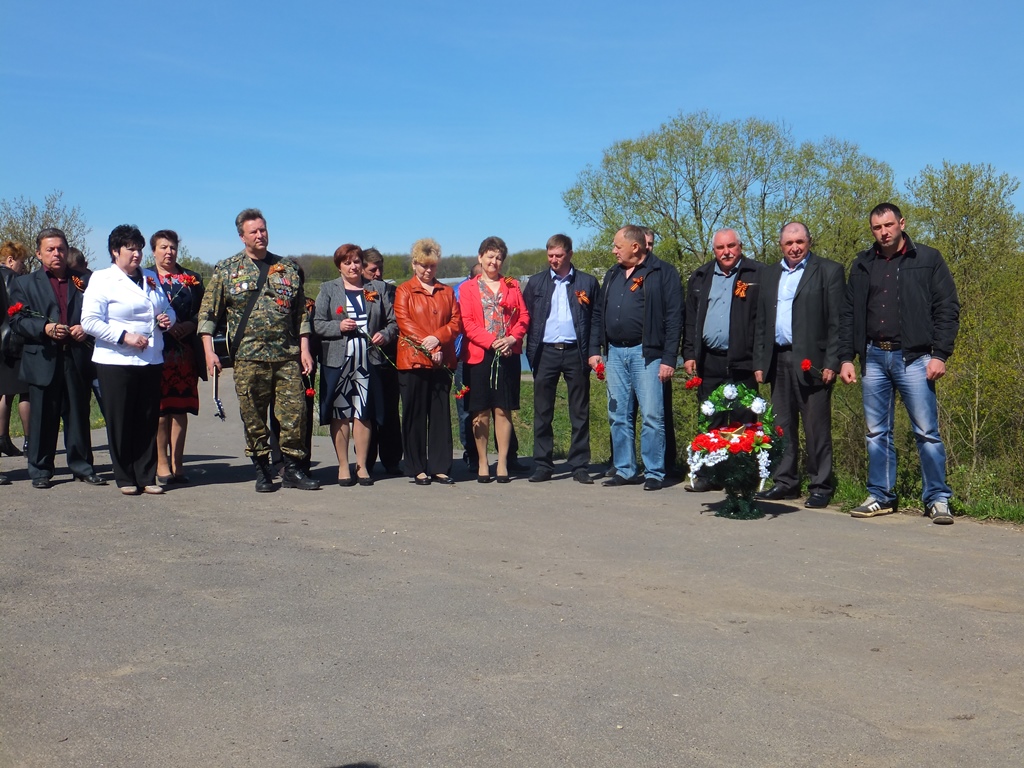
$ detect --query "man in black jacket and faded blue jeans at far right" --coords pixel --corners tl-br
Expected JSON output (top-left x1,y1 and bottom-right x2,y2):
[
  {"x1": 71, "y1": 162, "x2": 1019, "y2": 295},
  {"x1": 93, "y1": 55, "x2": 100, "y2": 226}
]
[{"x1": 840, "y1": 203, "x2": 959, "y2": 525}]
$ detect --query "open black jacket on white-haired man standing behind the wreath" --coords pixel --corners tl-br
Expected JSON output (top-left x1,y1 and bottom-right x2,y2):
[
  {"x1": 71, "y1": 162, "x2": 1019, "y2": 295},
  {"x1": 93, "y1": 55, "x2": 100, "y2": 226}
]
[{"x1": 683, "y1": 256, "x2": 762, "y2": 374}]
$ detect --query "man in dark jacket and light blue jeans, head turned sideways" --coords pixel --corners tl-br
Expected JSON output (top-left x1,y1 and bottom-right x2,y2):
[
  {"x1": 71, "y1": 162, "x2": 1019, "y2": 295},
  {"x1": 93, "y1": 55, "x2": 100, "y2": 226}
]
[{"x1": 601, "y1": 225, "x2": 683, "y2": 490}]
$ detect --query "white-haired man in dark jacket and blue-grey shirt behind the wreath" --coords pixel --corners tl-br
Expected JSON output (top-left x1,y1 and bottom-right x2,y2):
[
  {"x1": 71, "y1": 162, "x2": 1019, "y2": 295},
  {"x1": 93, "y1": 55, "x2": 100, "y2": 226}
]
[{"x1": 683, "y1": 229, "x2": 761, "y2": 493}]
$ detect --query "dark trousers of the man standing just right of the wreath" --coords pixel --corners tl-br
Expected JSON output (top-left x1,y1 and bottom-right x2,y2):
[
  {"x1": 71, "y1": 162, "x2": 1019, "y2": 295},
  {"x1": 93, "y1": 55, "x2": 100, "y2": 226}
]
[{"x1": 768, "y1": 349, "x2": 836, "y2": 496}]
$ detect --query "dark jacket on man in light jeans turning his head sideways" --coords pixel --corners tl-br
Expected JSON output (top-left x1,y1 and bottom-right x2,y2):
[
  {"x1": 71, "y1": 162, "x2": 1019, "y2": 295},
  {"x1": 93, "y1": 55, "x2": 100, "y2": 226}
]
[{"x1": 601, "y1": 253, "x2": 683, "y2": 368}]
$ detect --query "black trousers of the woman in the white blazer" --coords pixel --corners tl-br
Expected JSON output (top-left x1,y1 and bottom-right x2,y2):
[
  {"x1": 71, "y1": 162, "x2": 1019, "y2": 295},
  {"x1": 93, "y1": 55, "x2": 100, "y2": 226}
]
[{"x1": 96, "y1": 364, "x2": 164, "y2": 488}]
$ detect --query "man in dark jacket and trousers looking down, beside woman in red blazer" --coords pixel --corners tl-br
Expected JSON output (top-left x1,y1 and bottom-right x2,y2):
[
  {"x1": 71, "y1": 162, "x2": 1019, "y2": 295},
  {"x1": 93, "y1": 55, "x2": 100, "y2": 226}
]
[{"x1": 522, "y1": 234, "x2": 601, "y2": 485}]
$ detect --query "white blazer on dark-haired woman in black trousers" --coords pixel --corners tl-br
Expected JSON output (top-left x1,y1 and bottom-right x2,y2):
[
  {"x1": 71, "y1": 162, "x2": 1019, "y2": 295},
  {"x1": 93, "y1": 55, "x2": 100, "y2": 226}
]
[{"x1": 82, "y1": 264, "x2": 176, "y2": 366}]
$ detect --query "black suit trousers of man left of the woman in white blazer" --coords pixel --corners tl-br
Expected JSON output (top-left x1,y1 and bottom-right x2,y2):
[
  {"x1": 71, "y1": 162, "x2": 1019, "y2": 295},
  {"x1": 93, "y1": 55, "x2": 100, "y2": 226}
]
[{"x1": 28, "y1": 352, "x2": 95, "y2": 480}]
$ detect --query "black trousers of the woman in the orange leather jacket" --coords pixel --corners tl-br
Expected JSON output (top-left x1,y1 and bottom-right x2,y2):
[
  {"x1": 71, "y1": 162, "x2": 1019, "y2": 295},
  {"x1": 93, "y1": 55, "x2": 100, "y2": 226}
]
[{"x1": 398, "y1": 368, "x2": 452, "y2": 477}]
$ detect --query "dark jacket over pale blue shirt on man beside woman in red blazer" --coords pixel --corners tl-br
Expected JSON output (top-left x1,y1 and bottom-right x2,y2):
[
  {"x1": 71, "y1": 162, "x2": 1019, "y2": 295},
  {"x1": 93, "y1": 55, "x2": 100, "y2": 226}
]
[{"x1": 522, "y1": 266, "x2": 603, "y2": 371}]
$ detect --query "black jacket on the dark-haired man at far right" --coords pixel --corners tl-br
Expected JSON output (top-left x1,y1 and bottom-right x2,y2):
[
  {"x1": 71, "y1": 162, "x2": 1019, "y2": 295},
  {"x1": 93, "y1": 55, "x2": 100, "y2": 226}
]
[{"x1": 840, "y1": 232, "x2": 959, "y2": 372}]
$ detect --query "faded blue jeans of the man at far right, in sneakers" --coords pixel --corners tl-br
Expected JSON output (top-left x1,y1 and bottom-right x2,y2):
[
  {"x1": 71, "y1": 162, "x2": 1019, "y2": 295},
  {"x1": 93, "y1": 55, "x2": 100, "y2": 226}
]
[{"x1": 863, "y1": 344, "x2": 952, "y2": 506}]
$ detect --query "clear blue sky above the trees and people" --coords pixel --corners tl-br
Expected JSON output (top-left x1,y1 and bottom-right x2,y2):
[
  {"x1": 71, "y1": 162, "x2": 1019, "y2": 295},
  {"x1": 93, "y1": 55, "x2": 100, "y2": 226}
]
[{"x1": 0, "y1": 0, "x2": 1024, "y2": 263}]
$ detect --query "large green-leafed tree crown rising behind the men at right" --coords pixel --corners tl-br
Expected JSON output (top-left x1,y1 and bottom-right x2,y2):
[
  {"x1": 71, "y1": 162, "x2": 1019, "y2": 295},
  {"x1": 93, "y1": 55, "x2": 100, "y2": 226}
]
[{"x1": 562, "y1": 112, "x2": 893, "y2": 274}]
